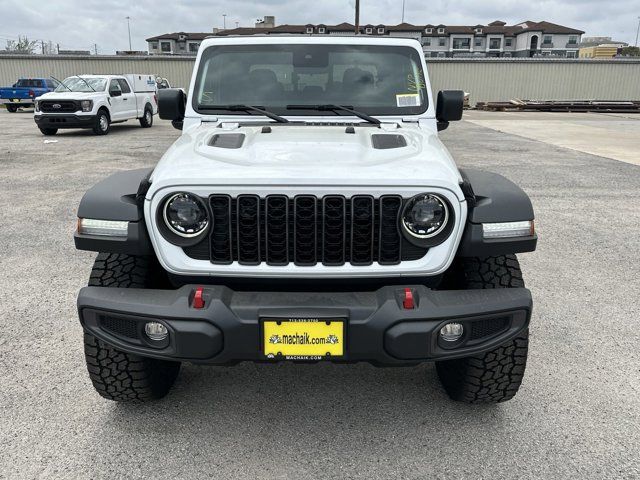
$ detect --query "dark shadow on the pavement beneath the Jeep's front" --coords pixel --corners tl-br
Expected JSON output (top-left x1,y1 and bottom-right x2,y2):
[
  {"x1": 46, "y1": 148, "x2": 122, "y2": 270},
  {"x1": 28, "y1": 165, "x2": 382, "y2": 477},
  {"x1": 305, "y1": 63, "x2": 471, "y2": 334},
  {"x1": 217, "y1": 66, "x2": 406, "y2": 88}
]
[{"x1": 100, "y1": 363, "x2": 500, "y2": 454}]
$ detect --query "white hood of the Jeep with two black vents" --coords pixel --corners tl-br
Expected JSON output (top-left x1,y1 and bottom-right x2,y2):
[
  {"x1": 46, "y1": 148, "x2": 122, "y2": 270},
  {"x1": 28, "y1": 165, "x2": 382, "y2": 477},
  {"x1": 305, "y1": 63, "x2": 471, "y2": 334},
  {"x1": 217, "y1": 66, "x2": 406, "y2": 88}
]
[{"x1": 148, "y1": 123, "x2": 464, "y2": 200}]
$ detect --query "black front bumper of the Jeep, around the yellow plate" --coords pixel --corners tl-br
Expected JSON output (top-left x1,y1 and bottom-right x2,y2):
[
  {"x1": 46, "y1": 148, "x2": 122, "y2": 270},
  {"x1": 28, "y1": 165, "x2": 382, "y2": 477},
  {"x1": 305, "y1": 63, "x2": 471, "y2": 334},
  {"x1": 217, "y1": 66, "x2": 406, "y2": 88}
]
[{"x1": 78, "y1": 285, "x2": 532, "y2": 365}]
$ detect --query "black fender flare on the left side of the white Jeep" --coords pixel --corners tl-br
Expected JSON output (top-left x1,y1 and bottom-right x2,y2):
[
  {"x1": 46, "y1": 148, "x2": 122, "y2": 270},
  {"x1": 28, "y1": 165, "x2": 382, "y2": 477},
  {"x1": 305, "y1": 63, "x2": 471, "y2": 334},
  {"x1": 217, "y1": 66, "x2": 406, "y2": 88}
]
[{"x1": 74, "y1": 168, "x2": 153, "y2": 255}]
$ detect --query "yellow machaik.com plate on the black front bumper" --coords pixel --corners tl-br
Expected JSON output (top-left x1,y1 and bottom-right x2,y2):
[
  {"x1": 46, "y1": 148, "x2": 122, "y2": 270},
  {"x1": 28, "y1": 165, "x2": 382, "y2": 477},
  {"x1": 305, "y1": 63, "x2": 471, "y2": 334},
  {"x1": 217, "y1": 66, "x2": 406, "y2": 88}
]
[{"x1": 262, "y1": 318, "x2": 345, "y2": 360}]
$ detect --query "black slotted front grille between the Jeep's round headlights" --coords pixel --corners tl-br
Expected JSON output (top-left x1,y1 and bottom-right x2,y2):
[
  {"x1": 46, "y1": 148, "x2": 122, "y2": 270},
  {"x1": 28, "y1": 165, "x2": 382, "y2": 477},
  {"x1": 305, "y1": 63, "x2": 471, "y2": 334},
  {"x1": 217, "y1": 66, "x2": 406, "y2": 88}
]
[{"x1": 184, "y1": 194, "x2": 427, "y2": 266}]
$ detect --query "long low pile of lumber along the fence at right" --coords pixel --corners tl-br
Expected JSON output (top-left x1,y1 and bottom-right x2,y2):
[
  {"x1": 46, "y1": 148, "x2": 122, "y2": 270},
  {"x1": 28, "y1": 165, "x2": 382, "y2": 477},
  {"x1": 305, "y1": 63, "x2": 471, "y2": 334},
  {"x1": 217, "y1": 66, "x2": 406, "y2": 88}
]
[{"x1": 476, "y1": 98, "x2": 640, "y2": 113}]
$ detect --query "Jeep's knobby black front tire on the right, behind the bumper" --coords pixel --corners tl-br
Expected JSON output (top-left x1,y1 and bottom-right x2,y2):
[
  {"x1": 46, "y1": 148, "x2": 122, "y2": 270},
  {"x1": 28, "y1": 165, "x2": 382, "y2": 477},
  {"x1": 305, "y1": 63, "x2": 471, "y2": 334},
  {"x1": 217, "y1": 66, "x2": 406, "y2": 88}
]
[{"x1": 436, "y1": 255, "x2": 529, "y2": 403}]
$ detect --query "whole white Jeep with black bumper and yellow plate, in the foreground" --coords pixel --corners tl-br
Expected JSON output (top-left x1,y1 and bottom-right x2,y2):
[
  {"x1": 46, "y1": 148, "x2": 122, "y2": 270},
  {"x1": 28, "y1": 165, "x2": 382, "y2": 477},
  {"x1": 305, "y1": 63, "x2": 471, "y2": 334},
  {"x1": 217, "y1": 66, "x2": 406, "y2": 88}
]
[{"x1": 75, "y1": 36, "x2": 537, "y2": 402}]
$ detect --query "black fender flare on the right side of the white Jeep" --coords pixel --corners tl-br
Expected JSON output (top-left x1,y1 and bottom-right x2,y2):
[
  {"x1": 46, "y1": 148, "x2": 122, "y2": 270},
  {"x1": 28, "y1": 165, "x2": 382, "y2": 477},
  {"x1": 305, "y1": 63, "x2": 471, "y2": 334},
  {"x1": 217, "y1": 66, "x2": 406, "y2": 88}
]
[{"x1": 457, "y1": 168, "x2": 538, "y2": 257}]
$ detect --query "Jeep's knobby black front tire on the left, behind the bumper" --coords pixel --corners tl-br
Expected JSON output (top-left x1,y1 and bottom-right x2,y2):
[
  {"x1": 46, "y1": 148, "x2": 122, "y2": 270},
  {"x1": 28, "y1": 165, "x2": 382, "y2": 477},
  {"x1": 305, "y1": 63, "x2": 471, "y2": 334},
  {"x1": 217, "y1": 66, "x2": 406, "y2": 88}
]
[{"x1": 84, "y1": 253, "x2": 180, "y2": 402}]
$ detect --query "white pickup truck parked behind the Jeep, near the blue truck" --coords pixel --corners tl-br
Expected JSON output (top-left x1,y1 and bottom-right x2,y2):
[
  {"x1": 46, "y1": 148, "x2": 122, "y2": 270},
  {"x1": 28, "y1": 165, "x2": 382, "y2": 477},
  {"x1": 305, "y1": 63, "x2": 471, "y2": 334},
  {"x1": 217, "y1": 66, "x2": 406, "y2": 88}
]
[{"x1": 34, "y1": 74, "x2": 158, "y2": 135}]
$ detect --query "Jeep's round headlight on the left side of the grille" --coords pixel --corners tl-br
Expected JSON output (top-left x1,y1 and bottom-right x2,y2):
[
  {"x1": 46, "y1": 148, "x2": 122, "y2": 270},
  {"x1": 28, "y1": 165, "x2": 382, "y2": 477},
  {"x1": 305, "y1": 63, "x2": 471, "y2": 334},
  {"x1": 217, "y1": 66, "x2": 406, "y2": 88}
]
[{"x1": 163, "y1": 193, "x2": 209, "y2": 238}]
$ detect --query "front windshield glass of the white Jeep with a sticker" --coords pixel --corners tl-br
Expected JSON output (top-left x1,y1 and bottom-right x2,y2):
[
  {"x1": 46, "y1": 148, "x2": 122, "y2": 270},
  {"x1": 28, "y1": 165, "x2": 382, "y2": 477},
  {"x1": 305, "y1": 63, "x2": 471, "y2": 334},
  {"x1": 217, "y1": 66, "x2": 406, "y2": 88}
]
[{"x1": 193, "y1": 44, "x2": 428, "y2": 115}]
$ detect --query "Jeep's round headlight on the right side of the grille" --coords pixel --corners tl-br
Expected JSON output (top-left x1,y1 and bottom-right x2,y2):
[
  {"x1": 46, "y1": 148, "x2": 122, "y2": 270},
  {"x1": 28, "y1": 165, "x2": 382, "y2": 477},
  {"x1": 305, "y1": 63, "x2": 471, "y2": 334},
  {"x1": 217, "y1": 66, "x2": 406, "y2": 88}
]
[{"x1": 402, "y1": 194, "x2": 449, "y2": 238}]
